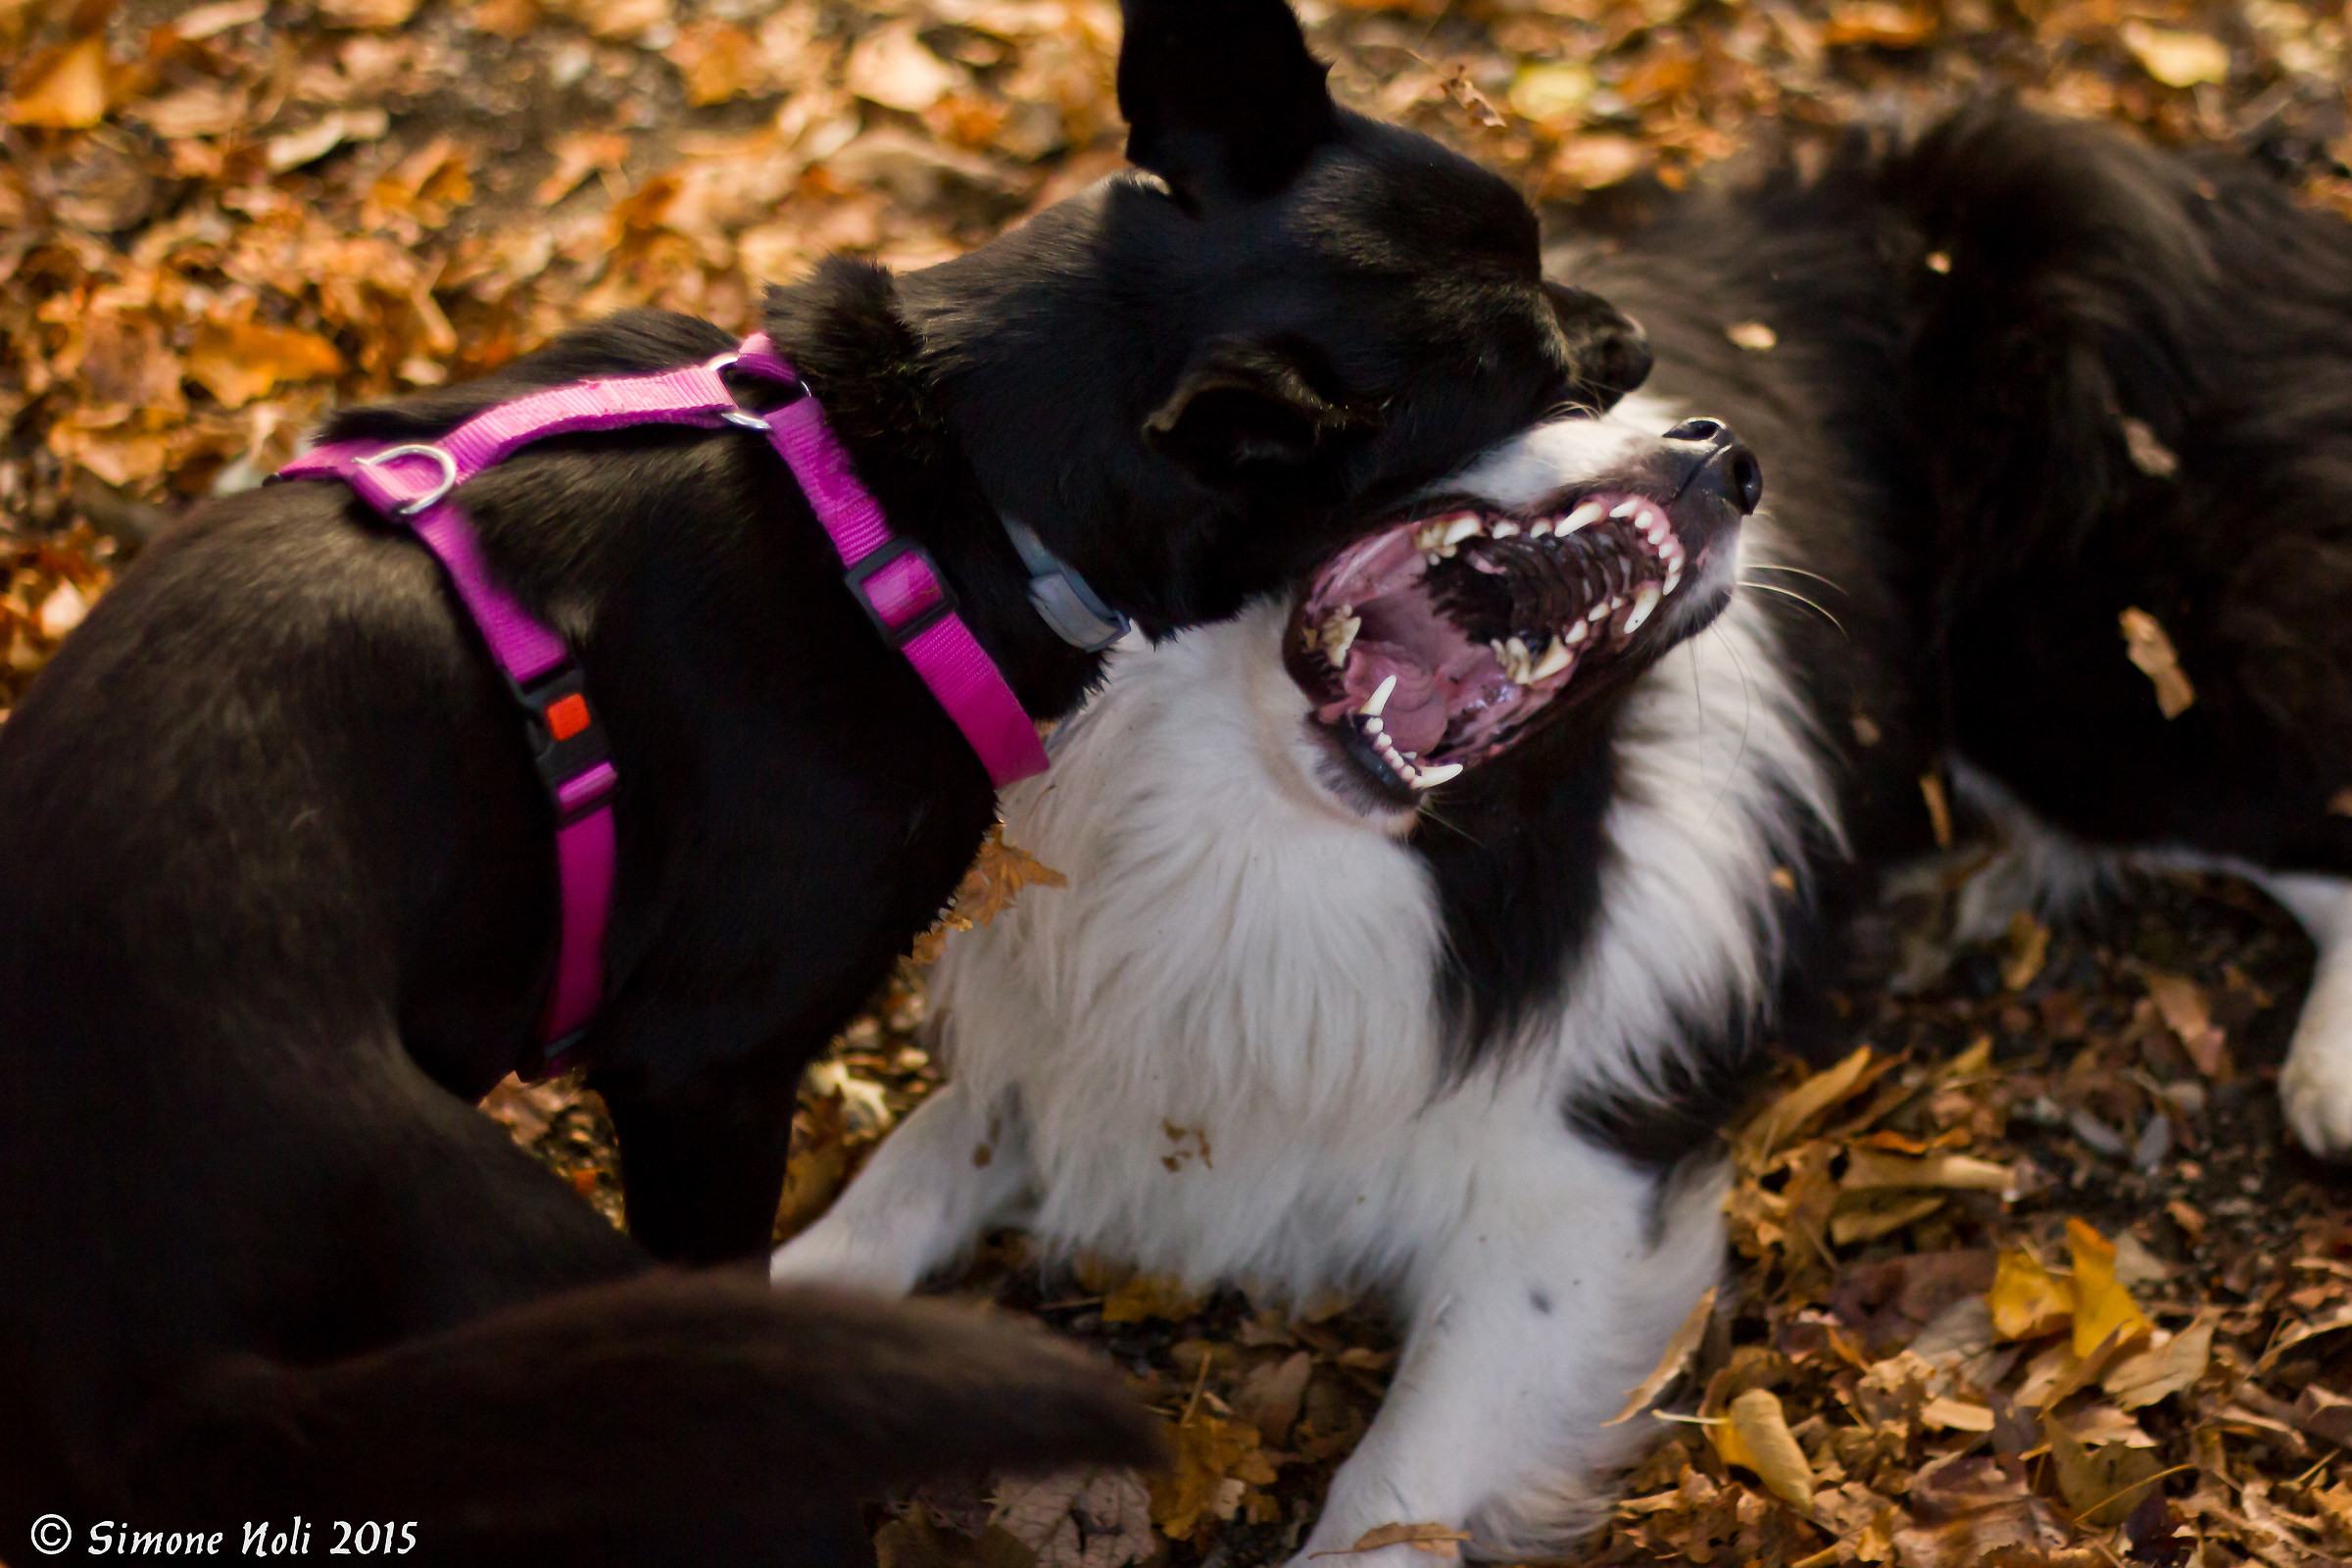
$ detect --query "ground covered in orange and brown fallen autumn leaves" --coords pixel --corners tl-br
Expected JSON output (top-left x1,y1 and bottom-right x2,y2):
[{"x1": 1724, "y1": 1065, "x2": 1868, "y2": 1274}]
[{"x1": 14, "y1": 0, "x2": 2352, "y2": 1568}]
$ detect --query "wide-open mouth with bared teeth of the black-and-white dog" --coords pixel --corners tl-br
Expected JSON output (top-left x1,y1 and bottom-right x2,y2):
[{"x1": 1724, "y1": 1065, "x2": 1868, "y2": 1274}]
[{"x1": 1284, "y1": 489, "x2": 1693, "y2": 797}]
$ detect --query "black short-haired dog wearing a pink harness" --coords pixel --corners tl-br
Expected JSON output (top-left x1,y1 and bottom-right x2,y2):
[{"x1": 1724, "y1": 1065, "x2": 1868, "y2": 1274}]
[{"x1": 0, "y1": 0, "x2": 1646, "y2": 1563}]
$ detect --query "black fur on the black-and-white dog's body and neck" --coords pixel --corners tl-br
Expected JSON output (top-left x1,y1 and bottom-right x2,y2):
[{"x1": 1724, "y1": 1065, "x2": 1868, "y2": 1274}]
[{"x1": 1416, "y1": 104, "x2": 2352, "y2": 1166}]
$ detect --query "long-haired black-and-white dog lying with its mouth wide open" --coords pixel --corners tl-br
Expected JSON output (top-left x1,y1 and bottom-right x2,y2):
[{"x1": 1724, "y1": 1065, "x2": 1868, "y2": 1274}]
[{"x1": 774, "y1": 108, "x2": 2352, "y2": 1561}]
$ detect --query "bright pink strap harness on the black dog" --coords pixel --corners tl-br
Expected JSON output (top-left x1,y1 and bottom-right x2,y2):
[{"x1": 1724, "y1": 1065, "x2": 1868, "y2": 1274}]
[{"x1": 277, "y1": 334, "x2": 1058, "y2": 1072}]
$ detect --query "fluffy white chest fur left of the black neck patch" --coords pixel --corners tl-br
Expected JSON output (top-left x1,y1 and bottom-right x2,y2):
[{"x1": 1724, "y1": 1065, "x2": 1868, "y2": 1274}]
[{"x1": 934, "y1": 609, "x2": 1514, "y2": 1289}]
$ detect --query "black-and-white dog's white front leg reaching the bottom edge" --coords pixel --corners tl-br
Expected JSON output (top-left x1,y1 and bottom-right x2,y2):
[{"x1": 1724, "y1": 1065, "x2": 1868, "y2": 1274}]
[{"x1": 1294, "y1": 1128, "x2": 1724, "y2": 1568}]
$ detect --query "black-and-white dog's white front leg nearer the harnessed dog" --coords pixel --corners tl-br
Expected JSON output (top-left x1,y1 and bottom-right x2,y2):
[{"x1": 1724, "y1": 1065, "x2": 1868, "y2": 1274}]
[{"x1": 769, "y1": 1084, "x2": 1030, "y2": 1293}]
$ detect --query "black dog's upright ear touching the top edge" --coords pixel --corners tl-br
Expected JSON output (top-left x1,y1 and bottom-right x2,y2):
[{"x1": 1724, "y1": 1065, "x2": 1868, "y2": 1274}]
[{"x1": 1119, "y1": 0, "x2": 1339, "y2": 212}]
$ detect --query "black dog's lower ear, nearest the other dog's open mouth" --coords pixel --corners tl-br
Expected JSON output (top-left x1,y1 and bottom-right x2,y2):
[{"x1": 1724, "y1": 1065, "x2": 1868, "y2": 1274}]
[{"x1": 1143, "y1": 338, "x2": 1381, "y2": 489}]
